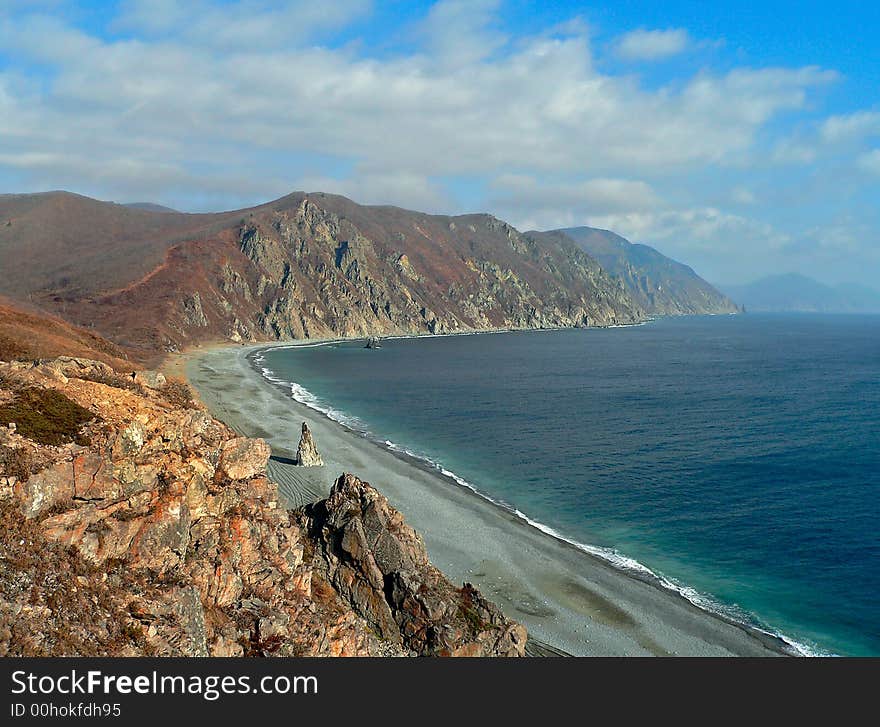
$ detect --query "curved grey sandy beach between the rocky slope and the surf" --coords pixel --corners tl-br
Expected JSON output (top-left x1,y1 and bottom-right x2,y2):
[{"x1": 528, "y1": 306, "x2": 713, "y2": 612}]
[{"x1": 184, "y1": 345, "x2": 788, "y2": 656}]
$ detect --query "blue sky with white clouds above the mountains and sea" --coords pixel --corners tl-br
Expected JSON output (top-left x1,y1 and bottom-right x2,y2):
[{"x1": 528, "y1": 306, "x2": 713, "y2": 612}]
[{"x1": 0, "y1": 0, "x2": 880, "y2": 287}]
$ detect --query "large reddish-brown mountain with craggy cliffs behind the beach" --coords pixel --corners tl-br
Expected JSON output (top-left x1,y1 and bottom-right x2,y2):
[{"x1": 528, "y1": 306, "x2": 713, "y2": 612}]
[{"x1": 0, "y1": 192, "x2": 645, "y2": 361}]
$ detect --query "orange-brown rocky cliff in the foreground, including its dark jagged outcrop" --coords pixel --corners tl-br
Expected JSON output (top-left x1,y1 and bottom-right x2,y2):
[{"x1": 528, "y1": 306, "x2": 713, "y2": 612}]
[{"x1": 0, "y1": 358, "x2": 525, "y2": 656}]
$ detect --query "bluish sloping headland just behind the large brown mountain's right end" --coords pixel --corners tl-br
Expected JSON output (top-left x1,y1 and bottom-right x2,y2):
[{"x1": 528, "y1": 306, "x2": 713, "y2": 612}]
[{"x1": 558, "y1": 227, "x2": 738, "y2": 315}]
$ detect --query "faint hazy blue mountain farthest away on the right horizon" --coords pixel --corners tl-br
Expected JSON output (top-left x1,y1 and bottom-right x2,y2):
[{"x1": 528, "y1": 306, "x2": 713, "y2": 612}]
[{"x1": 725, "y1": 273, "x2": 880, "y2": 313}]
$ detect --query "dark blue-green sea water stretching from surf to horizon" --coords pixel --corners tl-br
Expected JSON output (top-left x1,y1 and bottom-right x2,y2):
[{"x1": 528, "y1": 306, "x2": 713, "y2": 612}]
[{"x1": 262, "y1": 315, "x2": 880, "y2": 655}]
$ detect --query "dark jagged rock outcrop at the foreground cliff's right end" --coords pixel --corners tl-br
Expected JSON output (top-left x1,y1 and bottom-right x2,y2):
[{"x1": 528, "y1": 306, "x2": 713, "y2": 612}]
[{"x1": 302, "y1": 474, "x2": 526, "y2": 656}]
